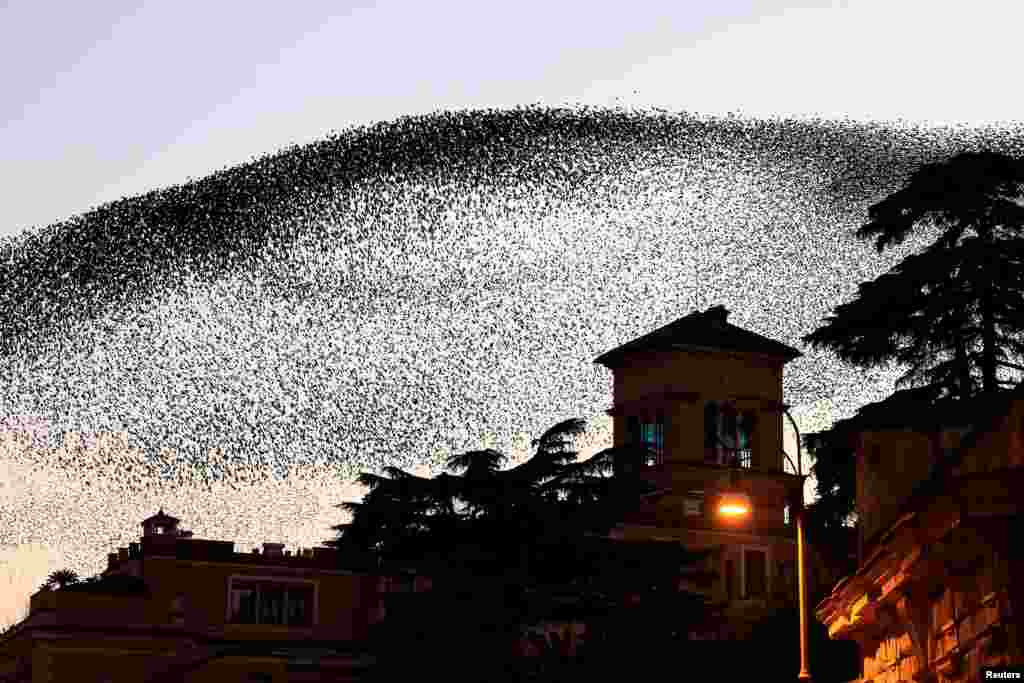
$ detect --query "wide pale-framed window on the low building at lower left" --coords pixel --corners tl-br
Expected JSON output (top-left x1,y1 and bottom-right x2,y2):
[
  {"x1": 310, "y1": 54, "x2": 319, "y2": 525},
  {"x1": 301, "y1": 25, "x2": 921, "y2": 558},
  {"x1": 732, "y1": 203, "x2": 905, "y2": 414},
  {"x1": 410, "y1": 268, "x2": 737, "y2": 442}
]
[{"x1": 230, "y1": 580, "x2": 313, "y2": 626}]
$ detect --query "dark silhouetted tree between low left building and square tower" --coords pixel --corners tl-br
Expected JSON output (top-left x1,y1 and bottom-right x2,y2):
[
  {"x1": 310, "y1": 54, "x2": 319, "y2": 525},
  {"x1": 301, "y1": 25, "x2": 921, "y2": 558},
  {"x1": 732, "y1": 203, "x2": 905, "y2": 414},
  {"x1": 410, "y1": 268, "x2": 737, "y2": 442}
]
[{"x1": 331, "y1": 420, "x2": 706, "y2": 680}]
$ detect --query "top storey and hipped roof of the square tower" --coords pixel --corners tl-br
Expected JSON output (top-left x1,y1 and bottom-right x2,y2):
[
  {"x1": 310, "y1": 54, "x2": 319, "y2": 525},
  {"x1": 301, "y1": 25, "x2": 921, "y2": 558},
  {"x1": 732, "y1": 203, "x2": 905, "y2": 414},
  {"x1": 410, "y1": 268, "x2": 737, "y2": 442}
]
[{"x1": 595, "y1": 305, "x2": 802, "y2": 471}]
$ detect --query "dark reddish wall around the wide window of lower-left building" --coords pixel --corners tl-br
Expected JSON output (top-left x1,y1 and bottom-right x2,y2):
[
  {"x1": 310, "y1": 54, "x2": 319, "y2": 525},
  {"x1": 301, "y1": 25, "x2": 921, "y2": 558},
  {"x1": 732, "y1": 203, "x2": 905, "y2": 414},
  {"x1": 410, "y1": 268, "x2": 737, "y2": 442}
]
[{"x1": 0, "y1": 557, "x2": 379, "y2": 683}]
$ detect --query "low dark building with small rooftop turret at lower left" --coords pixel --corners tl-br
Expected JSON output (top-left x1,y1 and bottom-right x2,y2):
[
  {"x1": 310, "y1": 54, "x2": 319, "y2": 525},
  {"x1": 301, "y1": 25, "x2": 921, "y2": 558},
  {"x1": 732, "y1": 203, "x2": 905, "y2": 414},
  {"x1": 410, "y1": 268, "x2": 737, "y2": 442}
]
[{"x1": 0, "y1": 510, "x2": 381, "y2": 683}]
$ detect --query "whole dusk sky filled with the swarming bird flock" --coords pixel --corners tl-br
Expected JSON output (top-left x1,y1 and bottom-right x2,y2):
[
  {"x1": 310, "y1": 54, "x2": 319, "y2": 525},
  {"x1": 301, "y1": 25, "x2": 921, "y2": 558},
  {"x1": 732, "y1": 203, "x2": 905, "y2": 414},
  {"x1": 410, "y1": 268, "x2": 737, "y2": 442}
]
[{"x1": 0, "y1": 0, "x2": 1024, "y2": 627}]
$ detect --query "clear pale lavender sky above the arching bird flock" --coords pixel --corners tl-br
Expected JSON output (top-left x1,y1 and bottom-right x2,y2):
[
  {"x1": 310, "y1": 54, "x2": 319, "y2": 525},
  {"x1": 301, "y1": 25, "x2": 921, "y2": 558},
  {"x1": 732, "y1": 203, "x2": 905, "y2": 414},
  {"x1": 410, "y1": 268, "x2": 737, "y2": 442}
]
[{"x1": 0, "y1": 0, "x2": 1024, "y2": 234}]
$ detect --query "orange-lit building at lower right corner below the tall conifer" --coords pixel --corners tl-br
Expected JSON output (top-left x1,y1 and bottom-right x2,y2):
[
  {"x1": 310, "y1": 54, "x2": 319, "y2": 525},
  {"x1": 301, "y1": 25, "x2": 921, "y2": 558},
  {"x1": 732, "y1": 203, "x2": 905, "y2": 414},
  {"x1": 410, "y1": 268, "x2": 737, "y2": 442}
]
[{"x1": 817, "y1": 385, "x2": 1024, "y2": 683}]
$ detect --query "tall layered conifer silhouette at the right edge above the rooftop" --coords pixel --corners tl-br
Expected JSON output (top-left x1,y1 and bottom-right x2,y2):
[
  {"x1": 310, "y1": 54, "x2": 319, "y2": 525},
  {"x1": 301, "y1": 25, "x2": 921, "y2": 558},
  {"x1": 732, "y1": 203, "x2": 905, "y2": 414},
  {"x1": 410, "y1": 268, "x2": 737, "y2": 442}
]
[{"x1": 803, "y1": 153, "x2": 1024, "y2": 397}]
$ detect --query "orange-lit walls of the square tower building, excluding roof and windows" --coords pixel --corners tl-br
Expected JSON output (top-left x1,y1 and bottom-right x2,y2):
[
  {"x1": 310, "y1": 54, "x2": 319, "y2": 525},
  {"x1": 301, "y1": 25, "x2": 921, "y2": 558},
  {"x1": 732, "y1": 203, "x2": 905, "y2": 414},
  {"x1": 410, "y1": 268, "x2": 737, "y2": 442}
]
[{"x1": 612, "y1": 344, "x2": 797, "y2": 618}]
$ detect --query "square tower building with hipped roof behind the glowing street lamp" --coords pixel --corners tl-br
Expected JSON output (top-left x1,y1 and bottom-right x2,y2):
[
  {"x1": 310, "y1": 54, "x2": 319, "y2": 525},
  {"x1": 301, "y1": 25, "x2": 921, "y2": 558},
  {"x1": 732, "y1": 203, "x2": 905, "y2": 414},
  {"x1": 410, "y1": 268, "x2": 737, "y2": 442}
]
[{"x1": 595, "y1": 306, "x2": 802, "y2": 638}]
